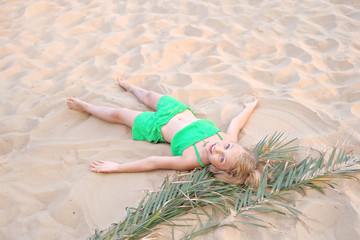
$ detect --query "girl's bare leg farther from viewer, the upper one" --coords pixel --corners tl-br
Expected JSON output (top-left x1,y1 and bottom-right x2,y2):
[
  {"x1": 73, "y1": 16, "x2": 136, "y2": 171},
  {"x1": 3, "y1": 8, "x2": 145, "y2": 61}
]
[{"x1": 117, "y1": 78, "x2": 163, "y2": 111}]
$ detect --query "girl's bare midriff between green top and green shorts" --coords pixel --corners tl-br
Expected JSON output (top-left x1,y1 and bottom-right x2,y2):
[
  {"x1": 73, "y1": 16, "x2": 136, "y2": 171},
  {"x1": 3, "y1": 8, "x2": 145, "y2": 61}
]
[{"x1": 161, "y1": 109, "x2": 199, "y2": 143}]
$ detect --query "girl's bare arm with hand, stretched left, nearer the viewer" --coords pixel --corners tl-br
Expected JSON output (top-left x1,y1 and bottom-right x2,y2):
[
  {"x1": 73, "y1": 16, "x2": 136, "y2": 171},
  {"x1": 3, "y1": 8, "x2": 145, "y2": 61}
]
[{"x1": 90, "y1": 156, "x2": 197, "y2": 173}]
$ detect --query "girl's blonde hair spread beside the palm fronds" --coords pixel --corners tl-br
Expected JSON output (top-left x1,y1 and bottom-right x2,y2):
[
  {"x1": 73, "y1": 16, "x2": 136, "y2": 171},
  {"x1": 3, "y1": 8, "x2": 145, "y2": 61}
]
[{"x1": 209, "y1": 148, "x2": 261, "y2": 188}]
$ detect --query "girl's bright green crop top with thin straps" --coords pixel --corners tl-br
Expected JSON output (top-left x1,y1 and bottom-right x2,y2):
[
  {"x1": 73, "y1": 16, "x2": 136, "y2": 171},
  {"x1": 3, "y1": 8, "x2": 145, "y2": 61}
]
[{"x1": 171, "y1": 120, "x2": 223, "y2": 167}]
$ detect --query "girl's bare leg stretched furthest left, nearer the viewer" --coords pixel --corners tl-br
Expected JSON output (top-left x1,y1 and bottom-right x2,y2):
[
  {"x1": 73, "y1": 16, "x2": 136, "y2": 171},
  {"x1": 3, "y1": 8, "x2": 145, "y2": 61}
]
[{"x1": 67, "y1": 97, "x2": 142, "y2": 127}]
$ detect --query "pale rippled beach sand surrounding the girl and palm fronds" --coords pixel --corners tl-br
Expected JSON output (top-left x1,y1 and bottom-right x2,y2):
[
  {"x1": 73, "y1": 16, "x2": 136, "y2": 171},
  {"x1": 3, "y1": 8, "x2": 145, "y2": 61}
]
[{"x1": 0, "y1": 0, "x2": 360, "y2": 240}]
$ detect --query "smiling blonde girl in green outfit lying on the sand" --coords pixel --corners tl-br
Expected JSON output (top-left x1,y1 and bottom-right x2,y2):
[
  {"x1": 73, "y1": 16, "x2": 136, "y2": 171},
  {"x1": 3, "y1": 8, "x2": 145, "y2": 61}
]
[{"x1": 67, "y1": 78, "x2": 261, "y2": 186}]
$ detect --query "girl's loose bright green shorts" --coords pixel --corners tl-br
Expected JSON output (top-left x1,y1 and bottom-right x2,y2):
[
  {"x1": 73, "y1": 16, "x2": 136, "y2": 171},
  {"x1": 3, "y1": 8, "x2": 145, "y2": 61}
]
[{"x1": 132, "y1": 95, "x2": 191, "y2": 143}]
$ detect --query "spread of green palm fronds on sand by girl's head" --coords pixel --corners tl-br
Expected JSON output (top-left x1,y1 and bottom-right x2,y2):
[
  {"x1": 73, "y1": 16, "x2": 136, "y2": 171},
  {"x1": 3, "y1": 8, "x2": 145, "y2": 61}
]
[{"x1": 92, "y1": 133, "x2": 360, "y2": 239}]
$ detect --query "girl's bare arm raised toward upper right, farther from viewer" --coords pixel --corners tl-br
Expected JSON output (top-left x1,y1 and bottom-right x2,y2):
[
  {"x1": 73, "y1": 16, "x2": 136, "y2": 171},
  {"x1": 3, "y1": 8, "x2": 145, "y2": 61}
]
[{"x1": 226, "y1": 99, "x2": 259, "y2": 142}]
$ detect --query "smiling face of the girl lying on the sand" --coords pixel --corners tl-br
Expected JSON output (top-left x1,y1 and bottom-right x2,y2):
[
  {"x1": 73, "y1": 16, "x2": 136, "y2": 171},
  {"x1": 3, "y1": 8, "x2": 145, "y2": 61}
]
[{"x1": 205, "y1": 140, "x2": 244, "y2": 170}]
